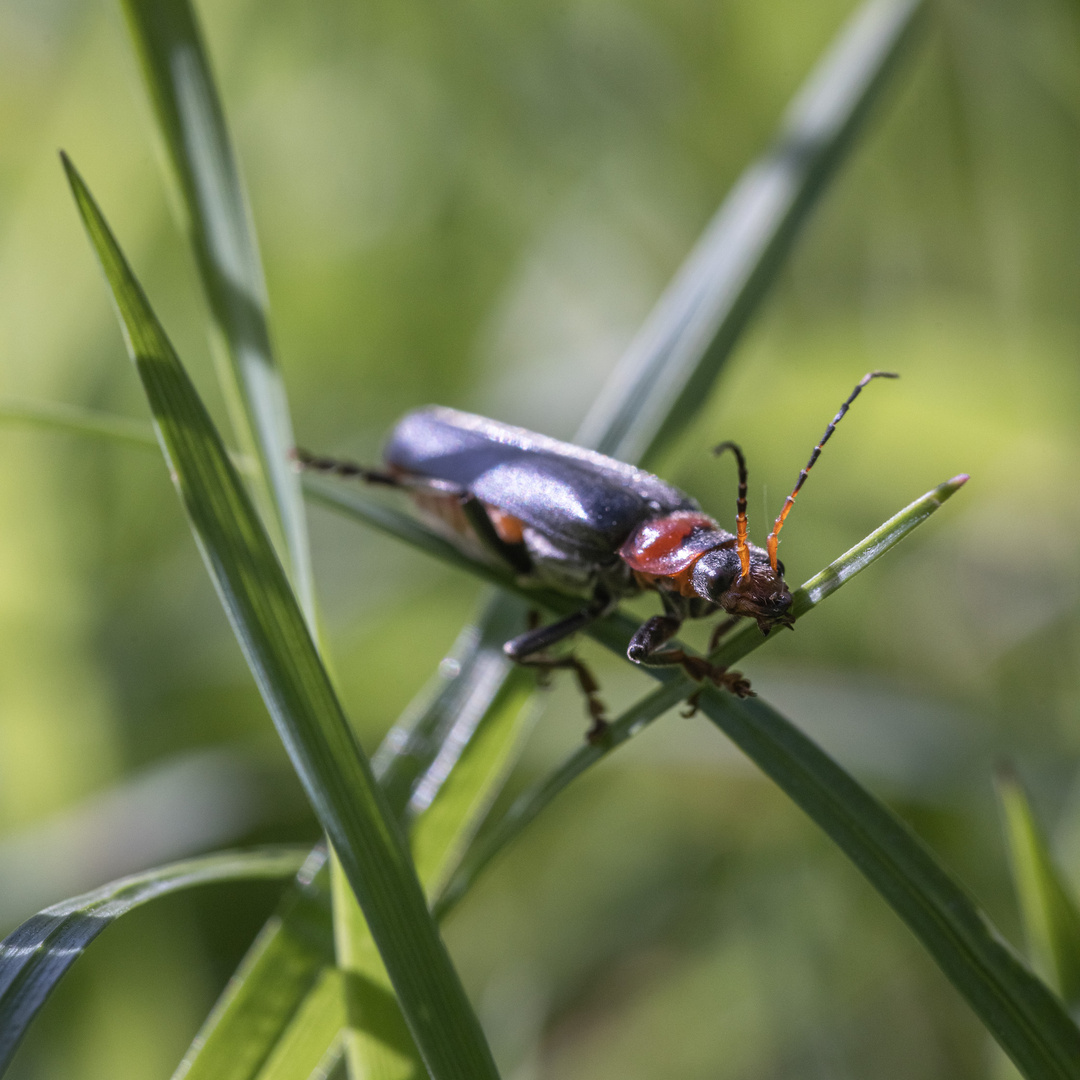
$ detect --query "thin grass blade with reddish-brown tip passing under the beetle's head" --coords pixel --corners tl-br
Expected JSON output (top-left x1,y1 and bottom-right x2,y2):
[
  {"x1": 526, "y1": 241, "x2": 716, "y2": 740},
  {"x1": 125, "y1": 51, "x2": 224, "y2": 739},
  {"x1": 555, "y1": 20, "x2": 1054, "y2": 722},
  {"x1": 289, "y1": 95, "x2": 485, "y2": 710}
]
[{"x1": 434, "y1": 475, "x2": 968, "y2": 919}]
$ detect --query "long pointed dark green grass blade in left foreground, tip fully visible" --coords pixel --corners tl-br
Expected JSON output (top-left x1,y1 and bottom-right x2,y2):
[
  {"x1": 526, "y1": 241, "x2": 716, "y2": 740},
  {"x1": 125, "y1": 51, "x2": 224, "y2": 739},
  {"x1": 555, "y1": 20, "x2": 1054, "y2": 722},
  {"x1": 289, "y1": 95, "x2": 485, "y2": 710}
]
[{"x1": 65, "y1": 150, "x2": 497, "y2": 1080}]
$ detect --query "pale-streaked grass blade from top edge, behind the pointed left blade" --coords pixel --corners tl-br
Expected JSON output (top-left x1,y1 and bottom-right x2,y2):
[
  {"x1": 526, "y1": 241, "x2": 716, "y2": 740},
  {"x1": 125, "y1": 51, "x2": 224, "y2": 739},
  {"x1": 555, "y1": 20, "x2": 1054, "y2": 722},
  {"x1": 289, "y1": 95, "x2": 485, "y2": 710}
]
[{"x1": 123, "y1": 0, "x2": 313, "y2": 623}]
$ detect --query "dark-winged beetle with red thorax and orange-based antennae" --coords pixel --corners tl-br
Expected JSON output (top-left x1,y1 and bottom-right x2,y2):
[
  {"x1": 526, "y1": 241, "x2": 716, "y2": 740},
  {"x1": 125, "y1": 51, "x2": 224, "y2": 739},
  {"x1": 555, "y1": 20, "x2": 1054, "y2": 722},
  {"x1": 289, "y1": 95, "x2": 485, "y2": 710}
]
[{"x1": 295, "y1": 372, "x2": 897, "y2": 742}]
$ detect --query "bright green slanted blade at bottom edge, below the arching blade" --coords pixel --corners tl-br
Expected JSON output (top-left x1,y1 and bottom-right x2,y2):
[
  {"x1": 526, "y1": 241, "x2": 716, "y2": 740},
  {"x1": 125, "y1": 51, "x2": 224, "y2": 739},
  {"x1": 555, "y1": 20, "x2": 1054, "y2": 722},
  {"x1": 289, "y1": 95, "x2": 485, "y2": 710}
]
[{"x1": 173, "y1": 848, "x2": 337, "y2": 1080}]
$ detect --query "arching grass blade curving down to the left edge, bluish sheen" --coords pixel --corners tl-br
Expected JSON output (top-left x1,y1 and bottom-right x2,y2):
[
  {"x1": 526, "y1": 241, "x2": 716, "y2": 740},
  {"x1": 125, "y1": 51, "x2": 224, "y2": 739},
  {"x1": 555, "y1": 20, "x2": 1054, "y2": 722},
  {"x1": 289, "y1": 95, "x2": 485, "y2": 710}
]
[{"x1": 0, "y1": 848, "x2": 307, "y2": 1072}]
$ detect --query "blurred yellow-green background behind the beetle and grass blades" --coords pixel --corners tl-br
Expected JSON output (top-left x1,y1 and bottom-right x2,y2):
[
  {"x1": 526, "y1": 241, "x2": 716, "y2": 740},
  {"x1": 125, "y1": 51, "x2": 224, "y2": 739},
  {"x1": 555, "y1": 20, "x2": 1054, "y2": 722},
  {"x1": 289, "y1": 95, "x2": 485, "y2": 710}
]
[{"x1": 0, "y1": 0, "x2": 1080, "y2": 1080}]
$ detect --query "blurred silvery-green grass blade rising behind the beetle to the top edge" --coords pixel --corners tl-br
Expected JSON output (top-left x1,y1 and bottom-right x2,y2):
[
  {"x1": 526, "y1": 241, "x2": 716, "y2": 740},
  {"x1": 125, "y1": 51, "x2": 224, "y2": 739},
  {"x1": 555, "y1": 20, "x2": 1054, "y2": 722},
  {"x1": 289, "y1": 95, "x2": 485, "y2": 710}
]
[{"x1": 578, "y1": 0, "x2": 924, "y2": 463}]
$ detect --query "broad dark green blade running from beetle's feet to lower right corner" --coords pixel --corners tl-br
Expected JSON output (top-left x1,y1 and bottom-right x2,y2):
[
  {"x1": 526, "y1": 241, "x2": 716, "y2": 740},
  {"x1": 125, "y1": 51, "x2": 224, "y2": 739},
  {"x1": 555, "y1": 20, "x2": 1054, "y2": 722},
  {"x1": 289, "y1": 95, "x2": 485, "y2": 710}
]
[{"x1": 701, "y1": 690, "x2": 1080, "y2": 1080}]
